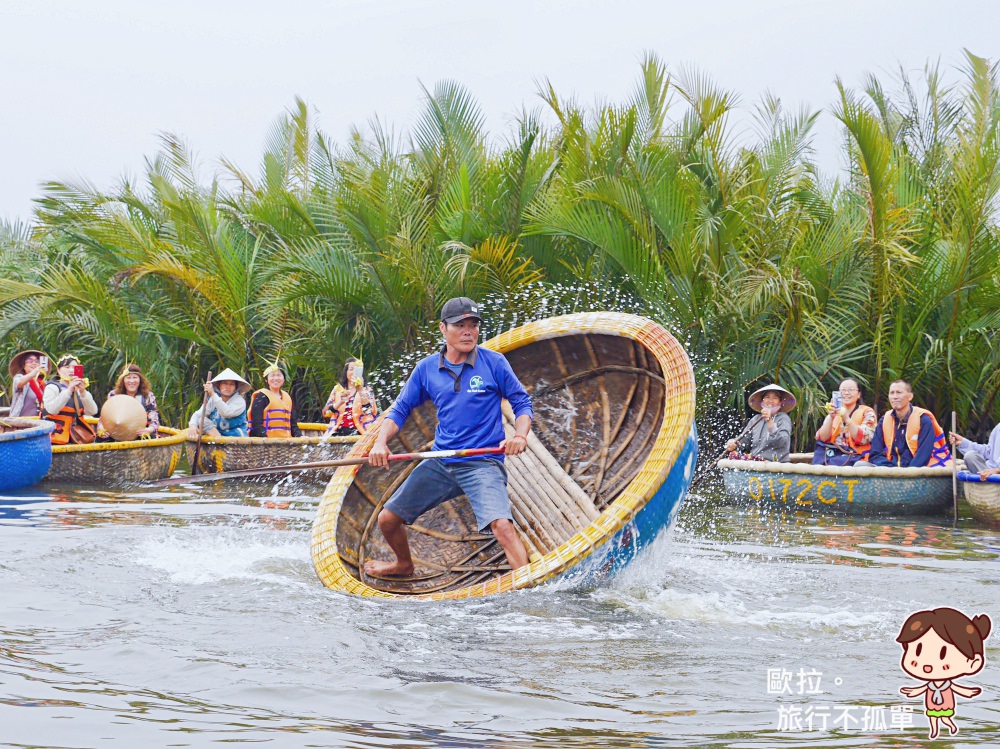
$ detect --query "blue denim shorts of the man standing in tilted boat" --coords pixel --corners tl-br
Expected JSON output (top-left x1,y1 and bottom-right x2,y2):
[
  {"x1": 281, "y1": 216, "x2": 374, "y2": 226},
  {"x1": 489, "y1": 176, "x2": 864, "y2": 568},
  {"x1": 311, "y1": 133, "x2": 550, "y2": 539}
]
[{"x1": 385, "y1": 458, "x2": 514, "y2": 533}]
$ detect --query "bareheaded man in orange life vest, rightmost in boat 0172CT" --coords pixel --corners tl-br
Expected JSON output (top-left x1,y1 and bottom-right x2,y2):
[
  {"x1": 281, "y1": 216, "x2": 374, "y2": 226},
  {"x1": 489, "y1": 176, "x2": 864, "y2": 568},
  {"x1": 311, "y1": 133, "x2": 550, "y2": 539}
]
[{"x1": 868, "y1": 380, "x2": 952, "y2": 468}]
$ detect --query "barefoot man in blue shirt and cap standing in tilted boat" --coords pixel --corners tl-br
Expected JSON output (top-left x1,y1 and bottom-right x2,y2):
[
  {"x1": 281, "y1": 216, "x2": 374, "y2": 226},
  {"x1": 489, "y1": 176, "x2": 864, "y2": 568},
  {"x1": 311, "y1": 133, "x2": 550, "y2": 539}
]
[{"x1": 365, "y1": 297, "x2": 533, "y2": 577}]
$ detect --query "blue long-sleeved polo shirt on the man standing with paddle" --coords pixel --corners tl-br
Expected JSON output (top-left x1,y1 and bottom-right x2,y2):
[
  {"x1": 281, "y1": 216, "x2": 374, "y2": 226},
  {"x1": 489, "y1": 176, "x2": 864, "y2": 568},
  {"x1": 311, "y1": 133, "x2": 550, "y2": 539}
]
[{"x1": 385, "y1": 346, "x2": 534, "y2": 463}]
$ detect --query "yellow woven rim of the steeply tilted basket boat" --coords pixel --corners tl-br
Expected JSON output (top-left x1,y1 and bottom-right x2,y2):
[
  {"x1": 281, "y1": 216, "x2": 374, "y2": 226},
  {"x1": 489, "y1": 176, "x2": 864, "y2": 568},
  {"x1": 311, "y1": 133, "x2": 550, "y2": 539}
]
[{"x1": 312, "y1": 312, "x2": 695, "y2": 600}]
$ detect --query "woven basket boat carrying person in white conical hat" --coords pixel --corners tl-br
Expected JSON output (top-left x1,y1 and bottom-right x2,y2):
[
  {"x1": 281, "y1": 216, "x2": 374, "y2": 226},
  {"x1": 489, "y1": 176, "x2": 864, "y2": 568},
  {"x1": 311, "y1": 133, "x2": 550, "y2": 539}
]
[{"x1": 187, "y1": 424, "x2": 360, "y2": 481}]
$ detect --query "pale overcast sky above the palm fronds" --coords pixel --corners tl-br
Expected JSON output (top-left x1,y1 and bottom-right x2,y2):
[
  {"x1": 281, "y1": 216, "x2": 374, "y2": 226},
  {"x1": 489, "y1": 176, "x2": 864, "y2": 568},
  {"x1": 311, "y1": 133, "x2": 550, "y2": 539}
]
[{"x1": 0, "y1": 0, "x2": 1000, "y2": 225}]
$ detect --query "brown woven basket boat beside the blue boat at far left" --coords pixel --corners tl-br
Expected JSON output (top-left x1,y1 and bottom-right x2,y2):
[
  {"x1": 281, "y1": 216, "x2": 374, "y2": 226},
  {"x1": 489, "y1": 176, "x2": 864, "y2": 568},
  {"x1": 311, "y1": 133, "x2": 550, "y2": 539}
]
[{"x1": 45, "y1": 418, "x2": 184, "y2": 486}]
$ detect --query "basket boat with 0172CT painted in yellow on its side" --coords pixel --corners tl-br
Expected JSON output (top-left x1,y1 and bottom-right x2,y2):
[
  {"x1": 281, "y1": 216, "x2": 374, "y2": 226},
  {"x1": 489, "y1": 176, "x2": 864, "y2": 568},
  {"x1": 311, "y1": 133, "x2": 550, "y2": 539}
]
[{"x1": 718, "y1": 453, "x2": 953, "y2": 515}]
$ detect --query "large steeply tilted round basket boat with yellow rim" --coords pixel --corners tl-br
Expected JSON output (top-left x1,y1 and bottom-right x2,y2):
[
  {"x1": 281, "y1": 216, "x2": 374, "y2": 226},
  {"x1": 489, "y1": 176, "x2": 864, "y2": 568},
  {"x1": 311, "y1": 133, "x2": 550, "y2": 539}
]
[{"x1": 312, "y1": 313, "x2": 697, "y2": 599}]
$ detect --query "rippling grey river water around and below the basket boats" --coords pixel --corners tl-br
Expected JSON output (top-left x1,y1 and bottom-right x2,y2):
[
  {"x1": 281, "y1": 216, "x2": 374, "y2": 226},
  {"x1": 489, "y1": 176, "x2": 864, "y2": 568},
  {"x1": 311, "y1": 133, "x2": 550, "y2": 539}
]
[{"x1": 0, "y1": 474, "x2": 1000, "y2": 749}]
